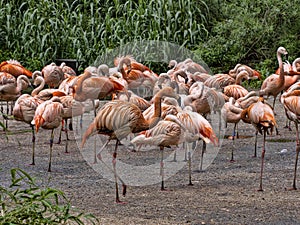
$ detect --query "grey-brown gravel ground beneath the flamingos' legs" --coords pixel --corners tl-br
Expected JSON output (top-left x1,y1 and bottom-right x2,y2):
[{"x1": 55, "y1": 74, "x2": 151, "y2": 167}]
[{"x1": 0, "y1": 99, "x2": 300, "y2": 224}]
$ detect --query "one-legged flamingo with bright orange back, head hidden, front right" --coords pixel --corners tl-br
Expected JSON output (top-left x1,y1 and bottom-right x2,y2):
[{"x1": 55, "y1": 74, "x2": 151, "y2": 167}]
[{"x1": 241, "y1": 97, "x2": 276, "y2": 191}]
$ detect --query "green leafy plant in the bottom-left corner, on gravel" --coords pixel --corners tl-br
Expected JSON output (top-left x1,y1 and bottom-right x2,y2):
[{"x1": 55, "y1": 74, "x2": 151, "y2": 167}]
[{"x1": 0, "y1": 169, "x2": 98, "y2": 224}]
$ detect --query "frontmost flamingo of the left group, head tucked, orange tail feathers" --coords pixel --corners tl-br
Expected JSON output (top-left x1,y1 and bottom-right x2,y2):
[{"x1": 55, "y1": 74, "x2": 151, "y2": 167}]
[{"x1": 31, "y1": 96, "x2": 63, "y2": 172}]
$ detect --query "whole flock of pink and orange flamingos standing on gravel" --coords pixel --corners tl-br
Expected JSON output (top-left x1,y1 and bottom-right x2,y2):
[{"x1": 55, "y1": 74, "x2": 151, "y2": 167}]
[{"x1": 0, "y1": 47, "x2": 300, "y2": 203}]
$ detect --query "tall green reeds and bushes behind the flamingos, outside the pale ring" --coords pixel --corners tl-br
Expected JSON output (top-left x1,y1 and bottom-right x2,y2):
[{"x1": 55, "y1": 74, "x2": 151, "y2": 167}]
[{"x1": 0, "y1": 0, "x2": 300, "y2": 75}]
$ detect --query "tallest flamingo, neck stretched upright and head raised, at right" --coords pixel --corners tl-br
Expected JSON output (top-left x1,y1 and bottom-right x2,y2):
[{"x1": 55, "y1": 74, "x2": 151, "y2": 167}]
[{"x1": 259, "y1": 47, "x2": 288, "y2": 109}]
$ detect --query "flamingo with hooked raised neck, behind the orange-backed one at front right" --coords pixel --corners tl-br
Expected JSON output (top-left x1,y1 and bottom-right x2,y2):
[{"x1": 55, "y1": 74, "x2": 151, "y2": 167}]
[{"x1": 223, "y1": 70, "x2": 249, "y2": 100}]
